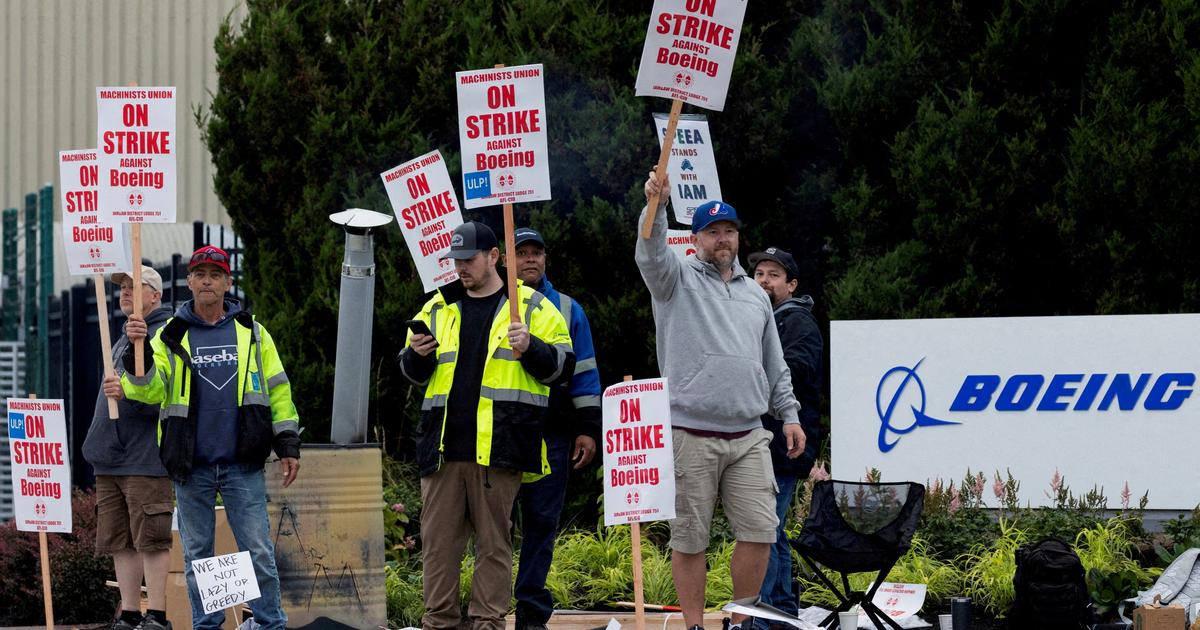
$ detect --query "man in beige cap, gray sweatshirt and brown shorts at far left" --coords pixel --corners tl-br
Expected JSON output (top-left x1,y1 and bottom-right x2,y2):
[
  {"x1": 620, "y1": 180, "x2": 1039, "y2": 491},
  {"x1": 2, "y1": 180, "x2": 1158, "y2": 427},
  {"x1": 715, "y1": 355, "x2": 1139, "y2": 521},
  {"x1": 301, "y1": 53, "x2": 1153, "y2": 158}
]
[{"x1": 83, "y1": 265, "x2": 175, "y2": 630}]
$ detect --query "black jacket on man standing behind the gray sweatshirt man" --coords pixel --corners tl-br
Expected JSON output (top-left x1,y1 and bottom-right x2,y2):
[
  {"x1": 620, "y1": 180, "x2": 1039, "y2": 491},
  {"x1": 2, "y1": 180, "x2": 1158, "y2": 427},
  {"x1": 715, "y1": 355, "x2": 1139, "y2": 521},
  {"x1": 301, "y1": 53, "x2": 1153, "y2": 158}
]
[{"x1": 762, "y1": 295, "x2": 824, "y2": 478}]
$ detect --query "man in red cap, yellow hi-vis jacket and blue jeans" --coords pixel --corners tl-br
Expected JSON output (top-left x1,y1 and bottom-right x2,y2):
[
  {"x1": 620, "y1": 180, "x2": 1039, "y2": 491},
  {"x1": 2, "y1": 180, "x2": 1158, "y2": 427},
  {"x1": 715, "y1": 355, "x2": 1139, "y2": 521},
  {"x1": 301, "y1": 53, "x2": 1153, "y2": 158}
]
[{"x1": 104, "y1": 245, "x2": 300, "y2": 630}]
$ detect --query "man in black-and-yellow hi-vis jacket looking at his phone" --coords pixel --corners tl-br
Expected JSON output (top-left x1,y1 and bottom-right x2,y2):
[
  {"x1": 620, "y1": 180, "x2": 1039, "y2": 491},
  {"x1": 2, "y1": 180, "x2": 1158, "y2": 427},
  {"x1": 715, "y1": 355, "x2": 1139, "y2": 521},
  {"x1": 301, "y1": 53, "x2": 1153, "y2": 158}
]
[{"x1": 398, "y1": 221, "x2": 575, "y2": 630}]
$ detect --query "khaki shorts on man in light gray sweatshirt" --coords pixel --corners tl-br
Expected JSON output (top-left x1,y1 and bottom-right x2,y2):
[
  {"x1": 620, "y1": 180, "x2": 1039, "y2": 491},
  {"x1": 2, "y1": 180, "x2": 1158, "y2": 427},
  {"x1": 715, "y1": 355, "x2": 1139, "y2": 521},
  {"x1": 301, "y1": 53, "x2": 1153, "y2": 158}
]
[{"x1": 671, "y1": 428, "x2": 779, "y2": 553}]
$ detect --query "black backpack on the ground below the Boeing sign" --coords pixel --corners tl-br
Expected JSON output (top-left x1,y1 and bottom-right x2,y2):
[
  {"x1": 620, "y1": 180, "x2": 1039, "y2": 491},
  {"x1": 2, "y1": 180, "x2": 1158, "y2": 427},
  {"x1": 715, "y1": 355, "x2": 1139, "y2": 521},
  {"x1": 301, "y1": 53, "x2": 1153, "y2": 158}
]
[{"x1": 1008, "y1": 538, "x2": 1092, "y2": 630}]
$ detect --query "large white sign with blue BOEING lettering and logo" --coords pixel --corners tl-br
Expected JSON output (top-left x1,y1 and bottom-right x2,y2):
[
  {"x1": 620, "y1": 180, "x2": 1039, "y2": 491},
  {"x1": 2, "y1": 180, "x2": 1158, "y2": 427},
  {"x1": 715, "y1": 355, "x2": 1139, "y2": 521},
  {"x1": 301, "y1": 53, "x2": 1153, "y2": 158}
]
[{"x1": 829, "y1": 314, "x2": 1200, "y2": 509}]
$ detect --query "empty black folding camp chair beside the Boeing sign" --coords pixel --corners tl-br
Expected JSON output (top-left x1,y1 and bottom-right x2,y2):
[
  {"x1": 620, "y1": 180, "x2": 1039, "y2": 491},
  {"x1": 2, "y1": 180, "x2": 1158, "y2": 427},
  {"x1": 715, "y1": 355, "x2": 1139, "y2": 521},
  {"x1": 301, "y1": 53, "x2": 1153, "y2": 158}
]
[{"x1": 791, "y1": 480, "x2": 925, "y2": 630}]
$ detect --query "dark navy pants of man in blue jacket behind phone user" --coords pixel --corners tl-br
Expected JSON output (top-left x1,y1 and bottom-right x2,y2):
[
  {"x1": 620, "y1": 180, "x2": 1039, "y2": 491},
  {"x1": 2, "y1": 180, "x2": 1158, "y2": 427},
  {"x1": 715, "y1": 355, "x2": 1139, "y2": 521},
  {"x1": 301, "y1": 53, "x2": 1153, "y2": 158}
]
[{"x1": 514, "y1": 433, "x2": 575, "y2": 624}]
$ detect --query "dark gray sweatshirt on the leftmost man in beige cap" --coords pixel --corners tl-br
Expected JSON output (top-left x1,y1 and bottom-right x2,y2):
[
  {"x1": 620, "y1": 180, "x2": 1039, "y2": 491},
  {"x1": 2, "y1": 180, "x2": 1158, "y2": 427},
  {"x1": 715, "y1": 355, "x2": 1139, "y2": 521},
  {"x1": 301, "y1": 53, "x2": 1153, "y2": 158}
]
[{"x1": 83, "y1": 306, "x2": 170, "y2": 476}]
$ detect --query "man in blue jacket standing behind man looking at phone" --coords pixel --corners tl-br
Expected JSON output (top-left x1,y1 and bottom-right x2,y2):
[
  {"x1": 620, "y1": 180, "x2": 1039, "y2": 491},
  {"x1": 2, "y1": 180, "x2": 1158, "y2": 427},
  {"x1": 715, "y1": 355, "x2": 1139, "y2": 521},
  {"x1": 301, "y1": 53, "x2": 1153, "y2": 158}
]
[{"x1": 512, "y1": 228, "x2": 600, "y2": 630}]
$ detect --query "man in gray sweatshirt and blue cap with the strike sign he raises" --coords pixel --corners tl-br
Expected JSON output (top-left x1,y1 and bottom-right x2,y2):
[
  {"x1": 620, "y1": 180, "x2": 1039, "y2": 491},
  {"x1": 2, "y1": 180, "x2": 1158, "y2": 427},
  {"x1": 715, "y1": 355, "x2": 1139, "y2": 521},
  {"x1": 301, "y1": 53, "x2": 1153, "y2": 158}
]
[{"x1": 635, "y1": 0, "x2": 804, "y2": 629}]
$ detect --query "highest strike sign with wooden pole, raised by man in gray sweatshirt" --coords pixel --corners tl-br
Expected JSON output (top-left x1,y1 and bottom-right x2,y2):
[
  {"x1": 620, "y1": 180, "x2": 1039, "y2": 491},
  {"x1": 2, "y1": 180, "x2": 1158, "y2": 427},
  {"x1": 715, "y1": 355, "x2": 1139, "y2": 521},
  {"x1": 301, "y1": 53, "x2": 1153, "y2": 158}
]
[{"x1": 635, "y1": 0, "x2": 746, "y2": 239}]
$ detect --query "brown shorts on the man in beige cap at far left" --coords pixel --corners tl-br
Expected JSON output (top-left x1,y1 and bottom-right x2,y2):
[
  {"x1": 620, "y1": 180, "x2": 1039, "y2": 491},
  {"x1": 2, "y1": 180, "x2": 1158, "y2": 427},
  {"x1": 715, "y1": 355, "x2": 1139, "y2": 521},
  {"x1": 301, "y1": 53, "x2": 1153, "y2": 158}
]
[{"x1": 96, "y1": 475, "x2": 175, "y2": 556}]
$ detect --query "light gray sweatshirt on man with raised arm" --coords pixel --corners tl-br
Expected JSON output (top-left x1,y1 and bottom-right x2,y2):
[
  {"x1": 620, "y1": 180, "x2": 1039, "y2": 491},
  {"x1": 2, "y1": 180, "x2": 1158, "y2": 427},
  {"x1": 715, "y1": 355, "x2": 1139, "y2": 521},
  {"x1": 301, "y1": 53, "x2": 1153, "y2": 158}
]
[{"x1": 635, "y1": 204, "x2": 800, "y2": 433}]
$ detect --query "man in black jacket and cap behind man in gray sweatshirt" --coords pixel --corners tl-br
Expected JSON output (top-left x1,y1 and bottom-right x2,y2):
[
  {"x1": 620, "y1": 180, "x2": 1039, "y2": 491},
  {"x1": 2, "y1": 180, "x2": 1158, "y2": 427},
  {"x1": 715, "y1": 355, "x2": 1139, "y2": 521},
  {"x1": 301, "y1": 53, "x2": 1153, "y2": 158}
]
[{"x1": 749, "y1": 247, "x2": 824, "y2": 626}]
